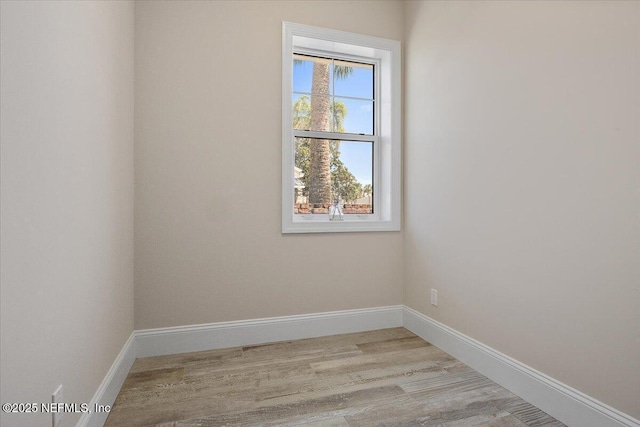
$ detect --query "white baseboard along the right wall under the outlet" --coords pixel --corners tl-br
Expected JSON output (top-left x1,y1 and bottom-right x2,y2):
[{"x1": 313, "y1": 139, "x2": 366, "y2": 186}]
[{"x1": 403, "y1": 306, "x2": 640, "y2": 427}]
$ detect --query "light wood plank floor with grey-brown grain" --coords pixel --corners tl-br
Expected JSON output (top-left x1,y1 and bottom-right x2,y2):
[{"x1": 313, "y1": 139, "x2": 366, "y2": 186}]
[{"x1": 106, "y1": 328, "x2": 563, "y2": 427}]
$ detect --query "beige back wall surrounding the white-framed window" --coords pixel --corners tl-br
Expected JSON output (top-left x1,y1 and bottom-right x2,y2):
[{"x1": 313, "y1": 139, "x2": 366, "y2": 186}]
[{"x1": 135, "y1": 1, "x2": 403, "y2": 329}]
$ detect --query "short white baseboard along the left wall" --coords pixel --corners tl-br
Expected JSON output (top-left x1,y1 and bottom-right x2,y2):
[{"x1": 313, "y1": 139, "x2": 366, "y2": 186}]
[{"x1": 76, "y1": 332, "x2": 136, "y2": 427}]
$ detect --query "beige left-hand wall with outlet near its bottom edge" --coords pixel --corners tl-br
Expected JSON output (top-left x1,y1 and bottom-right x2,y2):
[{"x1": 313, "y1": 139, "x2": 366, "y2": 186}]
[{"x1": 0, "y1": 1, "x2": 134, "y2": 427}]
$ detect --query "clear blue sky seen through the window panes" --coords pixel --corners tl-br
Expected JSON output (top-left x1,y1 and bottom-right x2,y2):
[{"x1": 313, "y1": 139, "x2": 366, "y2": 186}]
[{"x1": 293, "y1": 61, "x2": 373, "y2": 185}]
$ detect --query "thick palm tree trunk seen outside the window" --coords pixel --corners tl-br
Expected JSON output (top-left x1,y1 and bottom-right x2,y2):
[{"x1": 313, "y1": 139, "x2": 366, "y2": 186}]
[{"x1": 309, "y1": 61, "x2": 331, "y2": 203}]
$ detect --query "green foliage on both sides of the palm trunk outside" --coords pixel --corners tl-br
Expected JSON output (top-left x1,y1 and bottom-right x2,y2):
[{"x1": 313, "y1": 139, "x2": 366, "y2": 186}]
[{"x1": 293, "y1": 95, "x2": 363, "y2": 202}]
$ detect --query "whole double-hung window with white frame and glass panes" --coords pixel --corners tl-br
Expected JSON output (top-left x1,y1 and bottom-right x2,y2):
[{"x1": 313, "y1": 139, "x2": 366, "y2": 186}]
[{"x1": 282, "y1": 22, "x2": 401, "y2": 233}]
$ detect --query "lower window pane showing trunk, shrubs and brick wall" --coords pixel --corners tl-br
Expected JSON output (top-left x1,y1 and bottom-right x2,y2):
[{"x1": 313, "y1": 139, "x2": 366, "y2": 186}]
[{"x1": 293, "y1": 137, "x2": 373, "y2": 215}]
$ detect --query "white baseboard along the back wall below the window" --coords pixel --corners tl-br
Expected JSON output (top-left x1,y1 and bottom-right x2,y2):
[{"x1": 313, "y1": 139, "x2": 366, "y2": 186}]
[{"x1": 135, "y1": 305, "x2": 403, "y2": 357}]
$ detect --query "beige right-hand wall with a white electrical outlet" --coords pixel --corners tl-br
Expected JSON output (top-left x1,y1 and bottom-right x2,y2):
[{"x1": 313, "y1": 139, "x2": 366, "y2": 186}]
[{"x1": 404, "y1": 1, "x2": 640, "y2": 418}]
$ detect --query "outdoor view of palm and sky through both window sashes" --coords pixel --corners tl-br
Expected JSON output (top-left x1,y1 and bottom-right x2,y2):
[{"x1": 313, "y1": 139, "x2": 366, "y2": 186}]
[{"x1": 292, "y1": 53, "x2": 377, "y2": 215}]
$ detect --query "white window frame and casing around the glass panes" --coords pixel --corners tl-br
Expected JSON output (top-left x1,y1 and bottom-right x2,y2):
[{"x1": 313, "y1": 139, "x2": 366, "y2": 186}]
[{"x1": 282, "y1": 22, "x2": 402, "y2": 233}]
